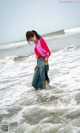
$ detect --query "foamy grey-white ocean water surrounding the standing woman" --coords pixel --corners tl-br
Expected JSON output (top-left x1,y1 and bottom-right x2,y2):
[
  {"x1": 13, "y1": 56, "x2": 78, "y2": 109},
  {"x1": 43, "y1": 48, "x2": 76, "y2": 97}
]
[{"x1": 0, "y1": 29, "x2": 80, "y2": 133}]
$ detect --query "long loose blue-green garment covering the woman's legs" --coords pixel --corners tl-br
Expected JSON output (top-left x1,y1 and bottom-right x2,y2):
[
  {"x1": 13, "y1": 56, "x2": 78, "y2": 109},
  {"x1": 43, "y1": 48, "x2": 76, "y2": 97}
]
[{"x1": 32, "y1": 58, "x2": 50, "y2": 90}]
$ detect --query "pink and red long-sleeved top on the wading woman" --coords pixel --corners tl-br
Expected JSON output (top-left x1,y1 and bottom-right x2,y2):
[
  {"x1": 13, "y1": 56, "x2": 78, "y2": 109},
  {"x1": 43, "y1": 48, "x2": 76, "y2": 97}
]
[{"x1": 34, "y1": 38, "x2": 51, "y2": 58}]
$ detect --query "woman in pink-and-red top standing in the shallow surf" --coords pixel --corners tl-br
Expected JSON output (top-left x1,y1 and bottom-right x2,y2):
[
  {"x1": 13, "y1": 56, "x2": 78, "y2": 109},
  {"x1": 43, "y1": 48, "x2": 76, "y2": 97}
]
[{"x1": 26, "y1": 30, "x2": 51, "y2": 90}]
